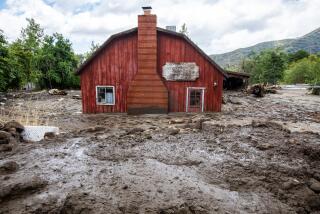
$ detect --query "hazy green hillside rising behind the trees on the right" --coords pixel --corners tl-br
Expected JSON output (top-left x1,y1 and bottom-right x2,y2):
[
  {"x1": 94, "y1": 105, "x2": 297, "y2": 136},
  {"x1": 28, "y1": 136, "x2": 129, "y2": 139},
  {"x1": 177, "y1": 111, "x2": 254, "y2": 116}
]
[{"x1": 211, "y1": 28, "x2": 320, "y2": 67}]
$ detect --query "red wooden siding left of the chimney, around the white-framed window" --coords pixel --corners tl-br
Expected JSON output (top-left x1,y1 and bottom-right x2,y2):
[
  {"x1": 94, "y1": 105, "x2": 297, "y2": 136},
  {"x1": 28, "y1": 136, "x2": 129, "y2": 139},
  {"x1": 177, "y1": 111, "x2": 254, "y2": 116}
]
[{"x1": 81, "y1": 33, "x2": 137, "y2": 113}]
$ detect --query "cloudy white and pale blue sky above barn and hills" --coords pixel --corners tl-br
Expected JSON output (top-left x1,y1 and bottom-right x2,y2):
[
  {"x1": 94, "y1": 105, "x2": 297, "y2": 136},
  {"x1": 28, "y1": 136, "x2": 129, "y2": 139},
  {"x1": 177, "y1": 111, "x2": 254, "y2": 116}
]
[{"x1": 0, "y1": 0, "x2": 320, "y2": 54}]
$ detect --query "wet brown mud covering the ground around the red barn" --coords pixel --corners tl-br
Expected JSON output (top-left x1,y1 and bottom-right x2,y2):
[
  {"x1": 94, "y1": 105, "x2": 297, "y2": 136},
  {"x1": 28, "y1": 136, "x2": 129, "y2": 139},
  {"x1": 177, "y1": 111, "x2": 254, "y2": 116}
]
[{"x1": 0, "y1": 90, "x2": 320, "y2": 214}]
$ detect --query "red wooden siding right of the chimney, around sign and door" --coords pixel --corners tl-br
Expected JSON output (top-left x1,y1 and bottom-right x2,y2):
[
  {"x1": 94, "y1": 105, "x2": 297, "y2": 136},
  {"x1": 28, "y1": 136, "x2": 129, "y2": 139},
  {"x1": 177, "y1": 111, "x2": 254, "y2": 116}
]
[{"x1": 158, "y1": 32, "x2": 223, "y2": 112}]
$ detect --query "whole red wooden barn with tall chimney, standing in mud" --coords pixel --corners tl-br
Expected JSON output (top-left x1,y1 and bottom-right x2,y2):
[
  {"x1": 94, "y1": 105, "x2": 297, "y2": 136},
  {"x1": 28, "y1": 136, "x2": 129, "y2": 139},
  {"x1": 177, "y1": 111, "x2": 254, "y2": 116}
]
[{"x1": 77, "y1": 7, "x2": 225, "y2": 114}]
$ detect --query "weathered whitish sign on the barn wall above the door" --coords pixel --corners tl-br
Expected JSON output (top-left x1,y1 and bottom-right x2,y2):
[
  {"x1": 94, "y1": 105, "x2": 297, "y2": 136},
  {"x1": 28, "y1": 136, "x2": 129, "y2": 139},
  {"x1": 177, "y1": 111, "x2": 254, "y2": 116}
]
[{"x1": 162, "y1": 62, "x2": 199, "y2": 81}]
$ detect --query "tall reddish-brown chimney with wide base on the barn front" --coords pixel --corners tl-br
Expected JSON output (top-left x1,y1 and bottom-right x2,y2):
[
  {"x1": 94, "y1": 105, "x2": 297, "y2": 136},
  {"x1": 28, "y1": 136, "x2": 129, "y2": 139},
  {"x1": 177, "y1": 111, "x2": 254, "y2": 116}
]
[{"x1": 127, "y1": 7, "x2": 168, "y2": 114}]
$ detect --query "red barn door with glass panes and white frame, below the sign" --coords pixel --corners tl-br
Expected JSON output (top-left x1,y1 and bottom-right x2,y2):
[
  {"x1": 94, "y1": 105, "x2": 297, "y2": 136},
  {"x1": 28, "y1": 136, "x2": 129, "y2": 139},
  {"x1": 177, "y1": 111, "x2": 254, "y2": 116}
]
[{"x1": 186, "y1": 88, "x2": 204, "y2": 112}]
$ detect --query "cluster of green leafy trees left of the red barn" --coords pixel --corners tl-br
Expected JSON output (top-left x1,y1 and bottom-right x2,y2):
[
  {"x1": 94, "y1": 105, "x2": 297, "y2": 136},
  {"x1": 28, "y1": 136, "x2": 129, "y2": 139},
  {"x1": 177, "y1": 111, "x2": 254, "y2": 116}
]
[{"x1": 0, "y1": 19, "x2": 80, "y2": 91}]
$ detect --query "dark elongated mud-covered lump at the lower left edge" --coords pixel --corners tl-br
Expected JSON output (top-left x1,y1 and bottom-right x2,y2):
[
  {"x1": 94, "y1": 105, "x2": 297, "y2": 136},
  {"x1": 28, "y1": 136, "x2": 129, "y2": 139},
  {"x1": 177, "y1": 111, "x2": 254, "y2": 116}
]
[{"x1": 0, "y1": 177, "x2": 48, "y2": 201}]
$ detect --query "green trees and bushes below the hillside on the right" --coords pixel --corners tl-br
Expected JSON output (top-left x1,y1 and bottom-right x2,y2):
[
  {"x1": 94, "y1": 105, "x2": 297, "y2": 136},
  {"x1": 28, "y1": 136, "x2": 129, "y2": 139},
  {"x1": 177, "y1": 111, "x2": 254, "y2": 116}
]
[{"x1": 241, "y1": 49, "x2": 320, "y2": 85}]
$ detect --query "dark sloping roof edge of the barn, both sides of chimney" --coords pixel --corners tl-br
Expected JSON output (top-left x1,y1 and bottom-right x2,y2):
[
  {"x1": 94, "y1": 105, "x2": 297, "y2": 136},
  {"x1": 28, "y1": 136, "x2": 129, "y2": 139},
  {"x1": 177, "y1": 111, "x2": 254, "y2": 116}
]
[{"x1": 76, "y1": 27, "x2": 228, "y2": 77}]
